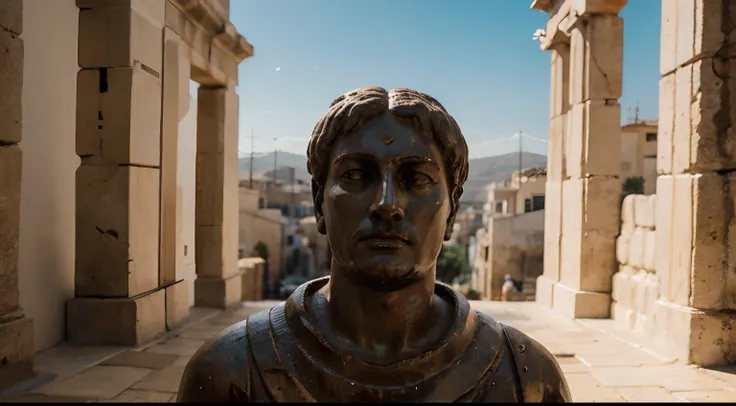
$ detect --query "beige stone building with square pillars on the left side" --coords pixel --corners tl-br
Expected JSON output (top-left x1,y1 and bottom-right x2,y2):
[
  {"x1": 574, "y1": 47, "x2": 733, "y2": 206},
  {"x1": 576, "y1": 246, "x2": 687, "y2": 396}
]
[{"x1": 0, "y1": 0, "x2": 253, "y2": 389}]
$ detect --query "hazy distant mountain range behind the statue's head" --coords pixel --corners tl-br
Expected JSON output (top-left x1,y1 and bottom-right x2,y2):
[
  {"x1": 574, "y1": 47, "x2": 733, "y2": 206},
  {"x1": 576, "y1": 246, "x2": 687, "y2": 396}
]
[{"x1": 238, "y1": 152, "x2": 547, "y2": 203}]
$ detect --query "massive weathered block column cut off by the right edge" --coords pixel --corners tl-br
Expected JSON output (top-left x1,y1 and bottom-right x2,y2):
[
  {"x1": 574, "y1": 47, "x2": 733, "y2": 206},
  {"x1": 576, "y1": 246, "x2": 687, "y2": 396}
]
[{"x1": 649, "y1": 0, "x2": 736, "y2": 366}]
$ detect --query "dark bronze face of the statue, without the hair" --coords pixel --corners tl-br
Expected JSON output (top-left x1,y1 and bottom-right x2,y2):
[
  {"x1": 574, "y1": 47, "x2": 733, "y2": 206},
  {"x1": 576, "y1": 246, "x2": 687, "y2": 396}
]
[{"x1": 322, "y1": 114, "x2": 450, "y2": 289}]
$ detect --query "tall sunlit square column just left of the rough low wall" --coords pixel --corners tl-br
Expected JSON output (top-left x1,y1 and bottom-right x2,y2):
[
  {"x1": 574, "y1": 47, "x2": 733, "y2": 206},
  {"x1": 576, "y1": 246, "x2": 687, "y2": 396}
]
[{"x1": 553, "y1": 9, "x2": 626, "y2": 318}]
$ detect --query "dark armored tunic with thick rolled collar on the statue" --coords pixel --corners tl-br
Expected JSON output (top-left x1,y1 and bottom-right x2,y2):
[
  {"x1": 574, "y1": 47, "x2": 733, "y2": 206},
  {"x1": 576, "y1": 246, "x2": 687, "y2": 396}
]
[{"x1": 178, "y1": 278, "x2": 570, "y2": 402}]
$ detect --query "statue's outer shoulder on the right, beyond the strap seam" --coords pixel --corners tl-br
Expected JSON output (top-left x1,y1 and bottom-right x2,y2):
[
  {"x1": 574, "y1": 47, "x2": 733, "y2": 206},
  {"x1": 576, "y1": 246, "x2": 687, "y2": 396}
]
[{"x1": 502, "y1": 324, "x2": 572, "y2": 403}]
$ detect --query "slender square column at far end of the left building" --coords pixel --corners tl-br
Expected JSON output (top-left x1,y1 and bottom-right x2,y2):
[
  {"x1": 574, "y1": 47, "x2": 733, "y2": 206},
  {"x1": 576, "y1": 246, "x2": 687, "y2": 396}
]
[{"x1": 194, "y1": 84, "x2": 242, "y2": 308}]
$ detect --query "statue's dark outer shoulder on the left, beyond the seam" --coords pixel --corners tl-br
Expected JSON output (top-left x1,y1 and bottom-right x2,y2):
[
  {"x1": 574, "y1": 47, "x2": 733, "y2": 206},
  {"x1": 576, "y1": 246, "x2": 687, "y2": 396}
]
[{"x1": 177, "y1": 321, "x2": 251, "y2": 403}]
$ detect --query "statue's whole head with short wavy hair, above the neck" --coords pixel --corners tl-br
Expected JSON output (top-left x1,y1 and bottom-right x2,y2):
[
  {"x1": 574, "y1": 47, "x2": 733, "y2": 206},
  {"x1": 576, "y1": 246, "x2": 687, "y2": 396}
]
[{"x1": 307, "y1": 87, "x2": 468, "y2": 290}]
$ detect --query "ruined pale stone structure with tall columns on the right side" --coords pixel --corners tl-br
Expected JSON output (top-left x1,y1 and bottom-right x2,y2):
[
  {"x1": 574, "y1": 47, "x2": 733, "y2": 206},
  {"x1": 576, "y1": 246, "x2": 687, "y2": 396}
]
[{"x1": 532, "y1": 0, "x2": 736, "y2": 366}]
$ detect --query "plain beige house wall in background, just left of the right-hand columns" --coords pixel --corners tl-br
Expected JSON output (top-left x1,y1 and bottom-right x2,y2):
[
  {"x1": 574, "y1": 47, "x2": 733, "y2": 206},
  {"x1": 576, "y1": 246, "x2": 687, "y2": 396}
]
[{"x1": 488, "y1": 210, "x2": 544, "y2": 300}]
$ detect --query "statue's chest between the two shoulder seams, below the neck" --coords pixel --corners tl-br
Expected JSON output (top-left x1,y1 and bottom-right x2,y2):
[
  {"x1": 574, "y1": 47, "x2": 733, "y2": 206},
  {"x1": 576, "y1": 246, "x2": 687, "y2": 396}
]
[{"x1": 248, "y1": 306, "x2": 519, "y2": 403}]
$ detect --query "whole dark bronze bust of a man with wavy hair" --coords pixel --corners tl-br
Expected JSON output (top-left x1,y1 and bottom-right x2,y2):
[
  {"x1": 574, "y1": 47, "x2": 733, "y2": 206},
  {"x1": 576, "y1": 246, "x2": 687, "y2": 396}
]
[{"x1": 178, "y1": 87, "x2": 570, "y2": 402}]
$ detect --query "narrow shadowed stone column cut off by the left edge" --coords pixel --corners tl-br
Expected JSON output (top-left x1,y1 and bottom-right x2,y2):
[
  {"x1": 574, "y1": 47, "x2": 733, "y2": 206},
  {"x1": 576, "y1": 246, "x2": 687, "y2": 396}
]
[{"x1": 0, "y1": 0, "x2": 33, "y2": 391}]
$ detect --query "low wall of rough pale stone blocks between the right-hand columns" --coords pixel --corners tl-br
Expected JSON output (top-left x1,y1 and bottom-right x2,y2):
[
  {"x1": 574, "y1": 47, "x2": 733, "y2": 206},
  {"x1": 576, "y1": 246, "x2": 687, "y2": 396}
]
[{"x1": 611, "y1": 195, "x2": 659, "y2": 333}]
